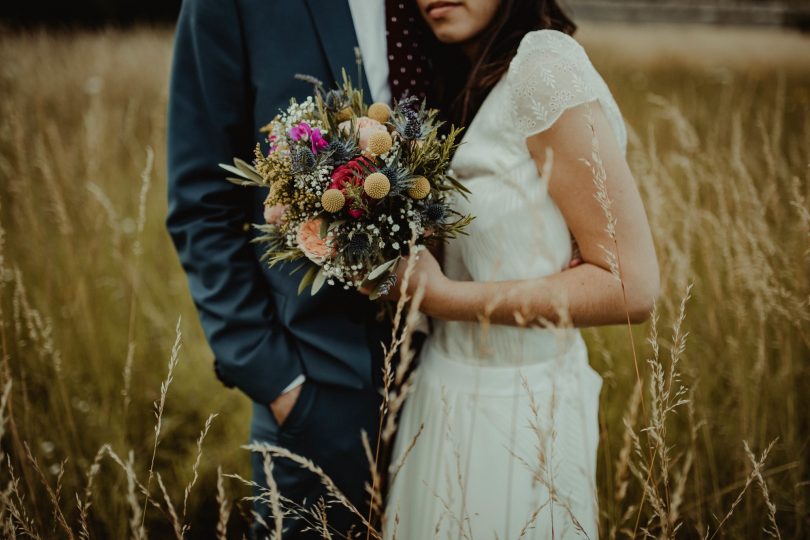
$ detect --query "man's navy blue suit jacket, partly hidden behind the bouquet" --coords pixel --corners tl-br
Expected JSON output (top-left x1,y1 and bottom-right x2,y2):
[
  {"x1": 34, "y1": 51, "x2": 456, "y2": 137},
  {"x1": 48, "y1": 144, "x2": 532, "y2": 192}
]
[{"x1": 167, "y1": 0, "x2": 390, "y2": 404}]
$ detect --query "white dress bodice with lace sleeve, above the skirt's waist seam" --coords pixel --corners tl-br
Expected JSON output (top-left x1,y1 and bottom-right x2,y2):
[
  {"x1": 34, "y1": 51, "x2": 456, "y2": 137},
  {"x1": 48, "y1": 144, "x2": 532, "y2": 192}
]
[{"x1": 428, "y1": 30, "x2": 627, "y2": 364}]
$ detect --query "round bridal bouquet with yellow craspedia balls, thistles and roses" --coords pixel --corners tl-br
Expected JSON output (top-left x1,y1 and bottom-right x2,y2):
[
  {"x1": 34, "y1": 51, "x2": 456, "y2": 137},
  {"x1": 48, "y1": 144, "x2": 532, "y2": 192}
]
[{"x1": 221, "y1": 74, "x2": 472, "y2": 298}]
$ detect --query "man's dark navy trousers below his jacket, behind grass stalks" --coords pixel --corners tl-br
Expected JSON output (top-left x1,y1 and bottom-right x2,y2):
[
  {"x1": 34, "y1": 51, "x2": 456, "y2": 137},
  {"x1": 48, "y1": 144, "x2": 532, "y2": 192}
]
[{"x1": 250, "y1": 380, "x2": 382, "y2": 540}]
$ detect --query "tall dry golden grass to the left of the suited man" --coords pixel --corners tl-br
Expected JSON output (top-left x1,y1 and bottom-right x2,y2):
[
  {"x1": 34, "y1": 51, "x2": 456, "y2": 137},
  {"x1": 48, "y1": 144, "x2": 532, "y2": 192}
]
[{"x1": 0, "y1": 29, "x2": 249, "y2": 538}]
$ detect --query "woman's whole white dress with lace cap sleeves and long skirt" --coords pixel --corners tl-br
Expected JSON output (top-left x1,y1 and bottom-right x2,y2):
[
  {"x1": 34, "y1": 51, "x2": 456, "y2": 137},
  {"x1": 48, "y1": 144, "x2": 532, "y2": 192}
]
[{"x1": 385, "y1": 30, "x2": 627, "y2": 540}]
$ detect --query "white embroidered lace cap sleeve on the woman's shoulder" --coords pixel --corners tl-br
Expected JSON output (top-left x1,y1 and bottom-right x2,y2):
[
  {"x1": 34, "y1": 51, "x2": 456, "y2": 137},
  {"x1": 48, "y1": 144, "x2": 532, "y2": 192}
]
[{"x1": 507, "y1": 30, "x2": 598, "y2": 137}]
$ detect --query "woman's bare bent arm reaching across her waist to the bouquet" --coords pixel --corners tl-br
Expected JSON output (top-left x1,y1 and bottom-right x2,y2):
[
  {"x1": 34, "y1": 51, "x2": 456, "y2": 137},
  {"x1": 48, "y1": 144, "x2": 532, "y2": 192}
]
[{"x1": 388, "y1": 102, "x2": 660, "y2": 326}]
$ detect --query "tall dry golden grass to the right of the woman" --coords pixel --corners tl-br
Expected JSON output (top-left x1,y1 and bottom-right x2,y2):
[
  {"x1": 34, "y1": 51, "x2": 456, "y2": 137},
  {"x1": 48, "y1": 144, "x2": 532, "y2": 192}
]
[{"x1": 583, "y1": 23, "x2": 810, "y2": 538}]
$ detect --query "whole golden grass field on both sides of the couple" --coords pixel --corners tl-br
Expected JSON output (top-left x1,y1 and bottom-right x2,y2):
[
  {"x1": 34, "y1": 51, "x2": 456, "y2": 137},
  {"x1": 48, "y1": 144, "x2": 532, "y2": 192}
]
[{"x1": 0, "y1": 22, "x2": 810, "y2": 539}]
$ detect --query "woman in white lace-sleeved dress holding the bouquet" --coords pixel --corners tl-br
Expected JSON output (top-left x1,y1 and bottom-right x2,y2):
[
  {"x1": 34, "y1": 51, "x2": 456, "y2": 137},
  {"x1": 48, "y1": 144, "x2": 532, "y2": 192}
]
[{"x1": 378, "y1": 0, "x2": 659, "y2": 540}]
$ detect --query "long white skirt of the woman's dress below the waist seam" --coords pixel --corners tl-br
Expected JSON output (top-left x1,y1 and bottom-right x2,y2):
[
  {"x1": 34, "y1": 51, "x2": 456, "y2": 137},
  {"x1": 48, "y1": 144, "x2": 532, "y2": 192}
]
[{"x1": 385, "y1": 335, "x2": 602, "y2": 540}]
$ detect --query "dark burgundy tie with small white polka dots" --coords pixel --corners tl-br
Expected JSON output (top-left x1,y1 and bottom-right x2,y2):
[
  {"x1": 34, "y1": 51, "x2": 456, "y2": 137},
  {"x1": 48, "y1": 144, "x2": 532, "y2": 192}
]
[{"x1": 385, "y1": 0, "x2": 429, "y2": 101}]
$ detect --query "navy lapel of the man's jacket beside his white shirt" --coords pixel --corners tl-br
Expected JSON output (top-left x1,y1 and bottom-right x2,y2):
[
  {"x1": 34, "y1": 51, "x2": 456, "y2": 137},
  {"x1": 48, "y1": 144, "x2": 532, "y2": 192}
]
[{"x1": 306, "y1": 0, "x2": 371, "y2": 99}]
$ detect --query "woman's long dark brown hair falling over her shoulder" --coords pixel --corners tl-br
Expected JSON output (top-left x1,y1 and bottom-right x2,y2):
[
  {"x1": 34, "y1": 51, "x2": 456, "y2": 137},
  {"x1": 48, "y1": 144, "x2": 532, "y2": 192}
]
[{"x1": 426, "y1": 0, "x2": 577, "y2": 126}]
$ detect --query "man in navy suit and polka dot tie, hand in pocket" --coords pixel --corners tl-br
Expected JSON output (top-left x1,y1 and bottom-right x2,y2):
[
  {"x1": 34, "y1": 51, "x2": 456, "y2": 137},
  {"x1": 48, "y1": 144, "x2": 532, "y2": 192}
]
[{"x1": 167, "y1": 0, "x2": 430, "y2": 538}]
